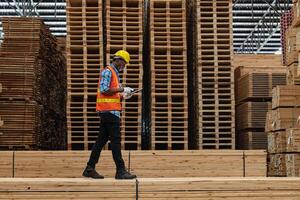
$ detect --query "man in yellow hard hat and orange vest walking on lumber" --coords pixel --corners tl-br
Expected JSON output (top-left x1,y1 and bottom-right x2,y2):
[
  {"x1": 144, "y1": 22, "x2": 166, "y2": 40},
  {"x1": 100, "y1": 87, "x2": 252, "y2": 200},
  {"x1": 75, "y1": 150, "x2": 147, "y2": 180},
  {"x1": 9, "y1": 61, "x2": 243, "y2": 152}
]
[{"x1": 83, "y1": 50, "x2": 136, "y2": 179}]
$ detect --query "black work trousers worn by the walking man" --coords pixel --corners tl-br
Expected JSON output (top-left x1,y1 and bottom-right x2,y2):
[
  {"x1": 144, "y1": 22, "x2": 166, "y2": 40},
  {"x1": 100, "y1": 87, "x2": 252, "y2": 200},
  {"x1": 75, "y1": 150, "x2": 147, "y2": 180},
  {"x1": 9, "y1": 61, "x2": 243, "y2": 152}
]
[{"x1": 87, "y1": 113, "x2": 125, "y2": 170}]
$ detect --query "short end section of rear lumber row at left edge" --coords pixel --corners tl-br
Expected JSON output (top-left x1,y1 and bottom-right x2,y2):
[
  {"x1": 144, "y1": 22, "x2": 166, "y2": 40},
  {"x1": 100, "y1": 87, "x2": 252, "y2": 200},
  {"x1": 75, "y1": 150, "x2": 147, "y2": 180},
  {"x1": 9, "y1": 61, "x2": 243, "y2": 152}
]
[{"x1": 0, "y1": 151, "x2": 14, "y2": 178}]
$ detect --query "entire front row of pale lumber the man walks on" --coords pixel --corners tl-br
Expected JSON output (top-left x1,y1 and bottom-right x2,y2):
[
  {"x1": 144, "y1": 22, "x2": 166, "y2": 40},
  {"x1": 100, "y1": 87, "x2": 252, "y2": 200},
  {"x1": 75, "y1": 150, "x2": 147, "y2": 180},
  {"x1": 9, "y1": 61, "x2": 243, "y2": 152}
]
[{"x1": 0, "y1": 177, "x2": 300, "y2": 200}]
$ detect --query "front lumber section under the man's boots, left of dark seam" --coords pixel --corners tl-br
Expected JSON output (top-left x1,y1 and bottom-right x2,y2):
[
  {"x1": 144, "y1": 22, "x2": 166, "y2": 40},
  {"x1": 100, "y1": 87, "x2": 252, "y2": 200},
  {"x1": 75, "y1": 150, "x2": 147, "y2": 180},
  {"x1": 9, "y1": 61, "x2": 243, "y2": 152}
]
[{"x1": 0, "y1": 178, "x2": 136, "y2": 200}]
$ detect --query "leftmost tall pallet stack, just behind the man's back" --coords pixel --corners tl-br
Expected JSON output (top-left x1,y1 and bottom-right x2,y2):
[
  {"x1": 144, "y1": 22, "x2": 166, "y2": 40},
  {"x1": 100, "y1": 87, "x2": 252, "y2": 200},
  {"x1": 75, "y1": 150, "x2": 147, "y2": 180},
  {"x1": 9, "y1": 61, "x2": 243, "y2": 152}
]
[{"x1": 66, "y1": 0, "x2": 103, "y2": 150}]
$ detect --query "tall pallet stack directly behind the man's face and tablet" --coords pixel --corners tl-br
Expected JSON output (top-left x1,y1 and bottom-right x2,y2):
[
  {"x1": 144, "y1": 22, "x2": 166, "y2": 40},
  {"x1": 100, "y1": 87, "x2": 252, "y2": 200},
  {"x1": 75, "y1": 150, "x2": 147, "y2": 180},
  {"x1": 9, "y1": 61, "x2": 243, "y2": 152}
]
[{"x1": 105, "y1": 0, "x2": 143, "y2": 150}]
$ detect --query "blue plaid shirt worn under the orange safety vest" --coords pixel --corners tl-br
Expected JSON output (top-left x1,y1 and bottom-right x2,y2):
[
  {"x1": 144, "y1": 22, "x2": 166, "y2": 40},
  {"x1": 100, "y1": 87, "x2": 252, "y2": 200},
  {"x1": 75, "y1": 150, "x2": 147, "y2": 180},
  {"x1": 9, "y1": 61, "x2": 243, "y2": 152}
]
[{"x1": 100, "y1": 64, "x2": 121, "y2": 118}]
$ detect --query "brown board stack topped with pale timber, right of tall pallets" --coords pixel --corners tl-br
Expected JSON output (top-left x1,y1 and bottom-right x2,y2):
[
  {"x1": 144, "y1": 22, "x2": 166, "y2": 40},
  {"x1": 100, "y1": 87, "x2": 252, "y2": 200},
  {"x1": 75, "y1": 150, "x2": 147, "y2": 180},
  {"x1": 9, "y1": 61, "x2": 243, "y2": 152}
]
[{"x1": 234, "y1": 55, "x2": 286, "y2": 149}]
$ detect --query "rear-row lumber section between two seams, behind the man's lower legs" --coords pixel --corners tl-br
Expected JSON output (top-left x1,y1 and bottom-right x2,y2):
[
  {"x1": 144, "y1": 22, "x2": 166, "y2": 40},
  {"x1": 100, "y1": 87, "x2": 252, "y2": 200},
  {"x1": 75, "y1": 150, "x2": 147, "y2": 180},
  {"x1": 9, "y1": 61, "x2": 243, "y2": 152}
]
[{"x1": 14, "y1": 151, "x2": 128, "y2": 178}]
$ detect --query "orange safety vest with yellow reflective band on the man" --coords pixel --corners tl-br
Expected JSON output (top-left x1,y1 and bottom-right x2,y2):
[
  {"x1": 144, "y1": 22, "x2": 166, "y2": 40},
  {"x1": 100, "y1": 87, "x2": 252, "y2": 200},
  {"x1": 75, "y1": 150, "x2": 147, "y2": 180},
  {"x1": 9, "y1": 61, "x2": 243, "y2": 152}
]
[{"x1": 96, "y1": 66, "x2": 121, "y2": 111}]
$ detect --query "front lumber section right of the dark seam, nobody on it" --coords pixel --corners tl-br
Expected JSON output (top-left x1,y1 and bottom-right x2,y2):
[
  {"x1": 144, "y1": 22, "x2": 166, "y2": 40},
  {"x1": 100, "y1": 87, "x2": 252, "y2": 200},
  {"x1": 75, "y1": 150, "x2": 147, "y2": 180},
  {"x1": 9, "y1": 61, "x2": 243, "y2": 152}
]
[{"x1": 139, "y1": 177, "x2": 300, "y2": 200}]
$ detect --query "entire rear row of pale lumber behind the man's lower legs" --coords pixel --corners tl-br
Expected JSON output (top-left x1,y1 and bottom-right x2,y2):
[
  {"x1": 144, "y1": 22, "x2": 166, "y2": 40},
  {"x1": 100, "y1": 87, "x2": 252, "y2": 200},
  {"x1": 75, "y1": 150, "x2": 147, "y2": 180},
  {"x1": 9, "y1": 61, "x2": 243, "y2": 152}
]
[{"x1": 0, "y1": 150, "x2": 266, "y2": 178}]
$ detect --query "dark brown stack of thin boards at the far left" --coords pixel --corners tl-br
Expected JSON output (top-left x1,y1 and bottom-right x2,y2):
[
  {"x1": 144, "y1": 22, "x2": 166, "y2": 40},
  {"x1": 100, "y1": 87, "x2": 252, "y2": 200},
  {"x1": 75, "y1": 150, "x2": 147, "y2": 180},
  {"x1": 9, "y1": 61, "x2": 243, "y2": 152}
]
[{"x1": 0, "y1": 18, "x2": 66, "y2": 149}]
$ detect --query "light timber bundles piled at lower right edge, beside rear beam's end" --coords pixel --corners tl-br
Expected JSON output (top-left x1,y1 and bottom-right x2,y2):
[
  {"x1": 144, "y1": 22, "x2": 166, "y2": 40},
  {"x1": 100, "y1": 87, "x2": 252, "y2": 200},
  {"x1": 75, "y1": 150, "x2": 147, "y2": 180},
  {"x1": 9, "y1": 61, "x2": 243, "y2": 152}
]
[{"x1": 266, "y1": 85, "x2": 300, "y2": 176}]
